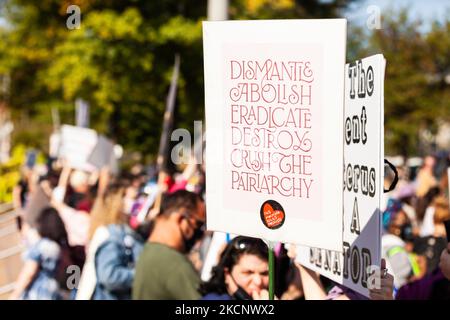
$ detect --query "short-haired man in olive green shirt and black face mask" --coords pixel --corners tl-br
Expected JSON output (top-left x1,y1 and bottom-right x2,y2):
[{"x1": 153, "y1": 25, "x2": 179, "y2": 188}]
[{"x1": 132, "y1": 190, "x2": 205, "y2": 300}]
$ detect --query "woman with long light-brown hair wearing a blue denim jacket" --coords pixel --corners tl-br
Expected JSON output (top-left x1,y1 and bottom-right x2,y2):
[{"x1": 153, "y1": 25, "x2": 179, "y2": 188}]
[{"x1": 76, "y1": 183, "x2": 144, "y2": 300}]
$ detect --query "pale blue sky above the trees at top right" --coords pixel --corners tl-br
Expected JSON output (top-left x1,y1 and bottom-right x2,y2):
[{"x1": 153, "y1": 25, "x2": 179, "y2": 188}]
[{"x1": 344, "y1": 0, "x2": 450, "y2": 32}]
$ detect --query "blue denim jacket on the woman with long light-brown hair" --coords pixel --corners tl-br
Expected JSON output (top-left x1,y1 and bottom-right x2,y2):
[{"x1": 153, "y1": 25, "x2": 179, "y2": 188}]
[{"x1": 93, "y1": 225, "x2": 144, "y2": 300}]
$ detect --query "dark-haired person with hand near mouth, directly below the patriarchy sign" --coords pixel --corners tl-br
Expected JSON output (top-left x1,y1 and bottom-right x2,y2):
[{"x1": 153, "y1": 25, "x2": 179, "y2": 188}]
[{"x1": 200, "y1": 236, "x2": 269, "y2": 300}]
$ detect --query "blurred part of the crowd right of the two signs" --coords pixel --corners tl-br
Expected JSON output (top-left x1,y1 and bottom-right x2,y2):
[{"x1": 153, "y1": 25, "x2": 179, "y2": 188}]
[{"x1": 382, "y1": 153, "x2": 450, "y2": 300}]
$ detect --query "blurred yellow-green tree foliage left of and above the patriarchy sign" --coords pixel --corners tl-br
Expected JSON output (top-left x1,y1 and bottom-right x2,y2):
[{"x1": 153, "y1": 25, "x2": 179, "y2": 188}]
[{"x1": 0, "y1": 0, "x2": 352, "y2": 154}]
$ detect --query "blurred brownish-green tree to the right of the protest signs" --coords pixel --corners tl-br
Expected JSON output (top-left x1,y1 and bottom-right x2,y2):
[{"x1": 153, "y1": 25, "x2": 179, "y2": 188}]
[{"x1": 357, "y1": 10, "x2": 450, "y2": 156}]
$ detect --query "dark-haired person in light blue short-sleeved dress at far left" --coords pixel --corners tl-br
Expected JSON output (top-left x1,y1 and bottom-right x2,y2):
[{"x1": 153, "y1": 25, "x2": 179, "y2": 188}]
[{"x1": 9, "y1": 207, "x2": 68, "y2": 300}]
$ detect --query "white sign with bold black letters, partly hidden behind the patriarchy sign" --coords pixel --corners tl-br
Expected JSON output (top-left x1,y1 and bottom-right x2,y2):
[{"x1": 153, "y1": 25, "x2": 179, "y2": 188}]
[{"x1": 297, "y1": 55, "x2": 386, "y2": 296}]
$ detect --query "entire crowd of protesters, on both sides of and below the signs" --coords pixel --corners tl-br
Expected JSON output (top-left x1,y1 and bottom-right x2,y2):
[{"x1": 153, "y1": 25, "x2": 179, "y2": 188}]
[{"x1": 6, "y1": 155, "x2": 450, "y2": 300}]
